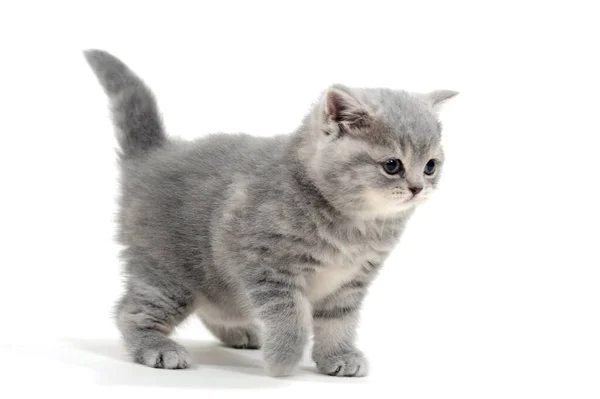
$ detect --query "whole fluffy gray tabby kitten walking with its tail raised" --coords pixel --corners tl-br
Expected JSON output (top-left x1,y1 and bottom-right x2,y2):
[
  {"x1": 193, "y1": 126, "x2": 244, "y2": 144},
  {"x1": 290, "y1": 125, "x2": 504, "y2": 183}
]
[{"x1": 85, "y1": 50, "x2": 457, "y2": 376}]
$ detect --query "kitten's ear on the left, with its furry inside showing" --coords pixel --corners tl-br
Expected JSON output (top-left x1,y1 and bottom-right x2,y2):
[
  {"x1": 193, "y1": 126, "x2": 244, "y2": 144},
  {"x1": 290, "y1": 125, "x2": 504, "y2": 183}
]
[{"x1": 324, "y1": 85, "x2": 371, "y2": 129}]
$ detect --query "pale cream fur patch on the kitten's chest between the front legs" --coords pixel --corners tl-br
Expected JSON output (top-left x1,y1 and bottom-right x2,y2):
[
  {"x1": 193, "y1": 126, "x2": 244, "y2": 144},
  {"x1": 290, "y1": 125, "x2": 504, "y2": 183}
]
[{"x1": 306, "y1": 264, "x2": 360, "y2": 302}]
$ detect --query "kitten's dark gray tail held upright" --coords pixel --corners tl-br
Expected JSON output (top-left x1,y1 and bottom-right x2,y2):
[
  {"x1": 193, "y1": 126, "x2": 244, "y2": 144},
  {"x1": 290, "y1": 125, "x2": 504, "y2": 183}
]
[{"x1": 83, "y1": 50, "x2": 167, "y2": 158}]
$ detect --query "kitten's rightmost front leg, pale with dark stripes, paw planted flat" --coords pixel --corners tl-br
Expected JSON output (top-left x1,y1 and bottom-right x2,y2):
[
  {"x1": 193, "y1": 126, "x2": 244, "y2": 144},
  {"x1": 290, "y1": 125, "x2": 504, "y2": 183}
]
[{"x1": 312, "y1": 281, "x2": 368, "y2": 377}]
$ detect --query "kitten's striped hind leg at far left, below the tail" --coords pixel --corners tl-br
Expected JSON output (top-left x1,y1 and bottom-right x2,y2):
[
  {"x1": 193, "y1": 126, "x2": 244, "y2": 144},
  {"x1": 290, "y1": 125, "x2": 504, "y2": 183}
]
[{"x1": 117, "y1": 281, "x2": 194, "y2": 369}]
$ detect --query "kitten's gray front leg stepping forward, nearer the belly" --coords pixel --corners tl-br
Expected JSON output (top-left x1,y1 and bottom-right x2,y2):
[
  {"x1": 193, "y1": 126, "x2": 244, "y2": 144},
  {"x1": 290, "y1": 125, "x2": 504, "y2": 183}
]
[{"x1": 246, "y1": 268, "x2": 312, "y2": 377}]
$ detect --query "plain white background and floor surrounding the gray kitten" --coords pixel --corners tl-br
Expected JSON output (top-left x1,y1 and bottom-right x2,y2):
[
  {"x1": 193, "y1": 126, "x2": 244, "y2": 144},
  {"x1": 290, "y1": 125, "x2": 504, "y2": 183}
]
[{"x1": 0, "y1": 1, "x2": 600, "y2": 398}]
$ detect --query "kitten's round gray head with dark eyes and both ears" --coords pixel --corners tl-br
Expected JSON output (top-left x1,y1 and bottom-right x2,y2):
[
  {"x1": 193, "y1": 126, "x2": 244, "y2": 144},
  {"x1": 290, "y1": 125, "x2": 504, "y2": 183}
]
[{"x1": 299, "y1": 85, "x2": 458, "y2": 218}]
